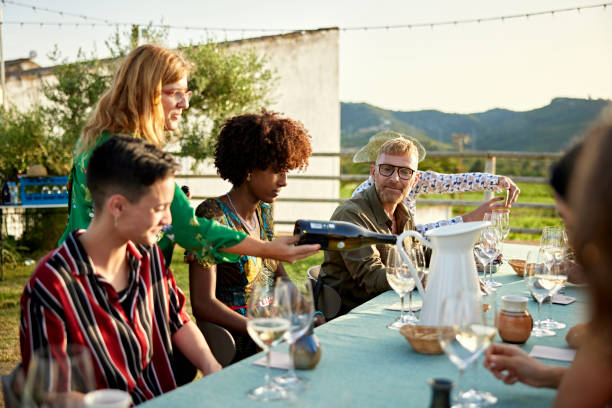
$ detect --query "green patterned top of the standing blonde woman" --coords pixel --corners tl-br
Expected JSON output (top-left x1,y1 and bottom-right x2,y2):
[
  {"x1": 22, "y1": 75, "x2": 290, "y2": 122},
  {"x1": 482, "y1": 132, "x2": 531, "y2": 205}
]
[{"x1": 59, "y1": 132, "x2": 247, "y2": 263}]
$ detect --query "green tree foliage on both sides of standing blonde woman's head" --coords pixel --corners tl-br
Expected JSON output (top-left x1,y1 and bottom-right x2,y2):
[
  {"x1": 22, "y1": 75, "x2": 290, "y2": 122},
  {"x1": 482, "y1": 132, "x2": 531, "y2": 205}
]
[{"x1": 0, "y1": 24, "x2": 274, "y2": 179}]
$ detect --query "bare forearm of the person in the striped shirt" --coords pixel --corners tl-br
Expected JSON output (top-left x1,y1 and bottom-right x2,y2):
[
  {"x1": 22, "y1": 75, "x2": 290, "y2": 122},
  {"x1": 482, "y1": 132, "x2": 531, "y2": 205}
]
[{"x1": 172, "y1": 322, "x2": 221, "y2": 376}]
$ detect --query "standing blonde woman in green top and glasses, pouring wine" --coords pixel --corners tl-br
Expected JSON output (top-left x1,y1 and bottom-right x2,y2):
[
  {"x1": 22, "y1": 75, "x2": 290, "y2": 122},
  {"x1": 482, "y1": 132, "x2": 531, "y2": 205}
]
[{"x1": 60, "y1": 44, "x2": 318, "y2": 263}]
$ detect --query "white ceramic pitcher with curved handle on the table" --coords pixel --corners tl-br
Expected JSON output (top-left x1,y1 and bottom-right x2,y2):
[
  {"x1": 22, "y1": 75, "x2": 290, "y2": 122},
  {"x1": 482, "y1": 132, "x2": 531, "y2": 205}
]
[{"x1": 397, "y1": 221, "x2": 490, "y2": 326}]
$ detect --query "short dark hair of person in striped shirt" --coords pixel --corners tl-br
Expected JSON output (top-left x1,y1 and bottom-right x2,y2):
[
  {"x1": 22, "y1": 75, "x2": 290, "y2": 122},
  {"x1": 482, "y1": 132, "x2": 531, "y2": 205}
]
[{"x1": 87, "y1": 136, "x2": 177, "y2": 210}]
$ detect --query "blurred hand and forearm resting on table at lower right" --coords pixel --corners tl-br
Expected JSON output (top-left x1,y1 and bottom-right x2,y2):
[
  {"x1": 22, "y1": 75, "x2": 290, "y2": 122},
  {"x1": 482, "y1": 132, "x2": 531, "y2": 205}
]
[{"x1": 484, "y1": 343, "x2": 567, "y2": 388}]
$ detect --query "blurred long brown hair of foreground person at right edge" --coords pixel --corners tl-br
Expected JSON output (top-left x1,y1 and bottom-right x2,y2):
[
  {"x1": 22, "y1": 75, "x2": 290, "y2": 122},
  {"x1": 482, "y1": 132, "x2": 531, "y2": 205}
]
[{"x1": 570, "y1": 115, "x2": 612, "y2": 341}]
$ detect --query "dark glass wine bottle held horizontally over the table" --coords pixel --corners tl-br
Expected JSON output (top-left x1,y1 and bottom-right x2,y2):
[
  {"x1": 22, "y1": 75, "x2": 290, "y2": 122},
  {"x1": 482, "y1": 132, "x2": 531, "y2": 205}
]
[{"x1": 293, "y1": 220, "x2": 397, "y2": 251}]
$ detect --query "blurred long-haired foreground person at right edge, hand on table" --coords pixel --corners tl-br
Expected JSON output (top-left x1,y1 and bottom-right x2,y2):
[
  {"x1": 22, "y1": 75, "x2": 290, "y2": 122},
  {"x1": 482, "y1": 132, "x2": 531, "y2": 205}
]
[{"x1": 485, "y1": 111, "x2": 612, "y2": 407}]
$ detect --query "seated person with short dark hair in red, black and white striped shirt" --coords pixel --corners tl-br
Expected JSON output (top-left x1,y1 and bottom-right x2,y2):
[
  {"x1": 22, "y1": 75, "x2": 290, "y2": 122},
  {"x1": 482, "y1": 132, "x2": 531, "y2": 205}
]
[{"x1": 19, "y1": 136, "x2": 220, "y2": 403}]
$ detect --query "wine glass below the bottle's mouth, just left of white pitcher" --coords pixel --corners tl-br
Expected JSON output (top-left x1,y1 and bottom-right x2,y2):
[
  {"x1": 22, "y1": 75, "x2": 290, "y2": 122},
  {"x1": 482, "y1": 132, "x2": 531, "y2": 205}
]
[{"x1": 386, "y1": 246, "x2": 418, "y2": 330}]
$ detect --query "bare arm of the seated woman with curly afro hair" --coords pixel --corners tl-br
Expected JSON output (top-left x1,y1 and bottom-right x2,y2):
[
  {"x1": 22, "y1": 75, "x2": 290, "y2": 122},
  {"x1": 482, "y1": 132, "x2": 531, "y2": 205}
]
[{"x1": 189, "y1": 261, "x2": 247, "y2": 334}]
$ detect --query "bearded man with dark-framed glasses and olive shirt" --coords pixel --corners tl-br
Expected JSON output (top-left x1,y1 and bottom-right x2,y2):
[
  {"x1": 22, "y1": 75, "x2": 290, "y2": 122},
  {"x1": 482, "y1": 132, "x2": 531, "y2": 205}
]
[{"x1": 319, "y1": 138, "x2": 419, "y2": 314}]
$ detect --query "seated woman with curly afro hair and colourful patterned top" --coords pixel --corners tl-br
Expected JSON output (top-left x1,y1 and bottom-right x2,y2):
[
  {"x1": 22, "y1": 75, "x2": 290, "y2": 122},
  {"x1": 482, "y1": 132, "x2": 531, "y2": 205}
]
[{"x1": 186, "y1": 110, "x2": 312, "y2": 361}]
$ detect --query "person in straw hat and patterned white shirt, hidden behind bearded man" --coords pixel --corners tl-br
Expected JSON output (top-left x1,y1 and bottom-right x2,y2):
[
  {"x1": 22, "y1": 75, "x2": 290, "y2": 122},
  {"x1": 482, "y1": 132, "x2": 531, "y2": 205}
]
[{"x1": 353, "y1": 130, "x2": 520, "y2": 234}]
